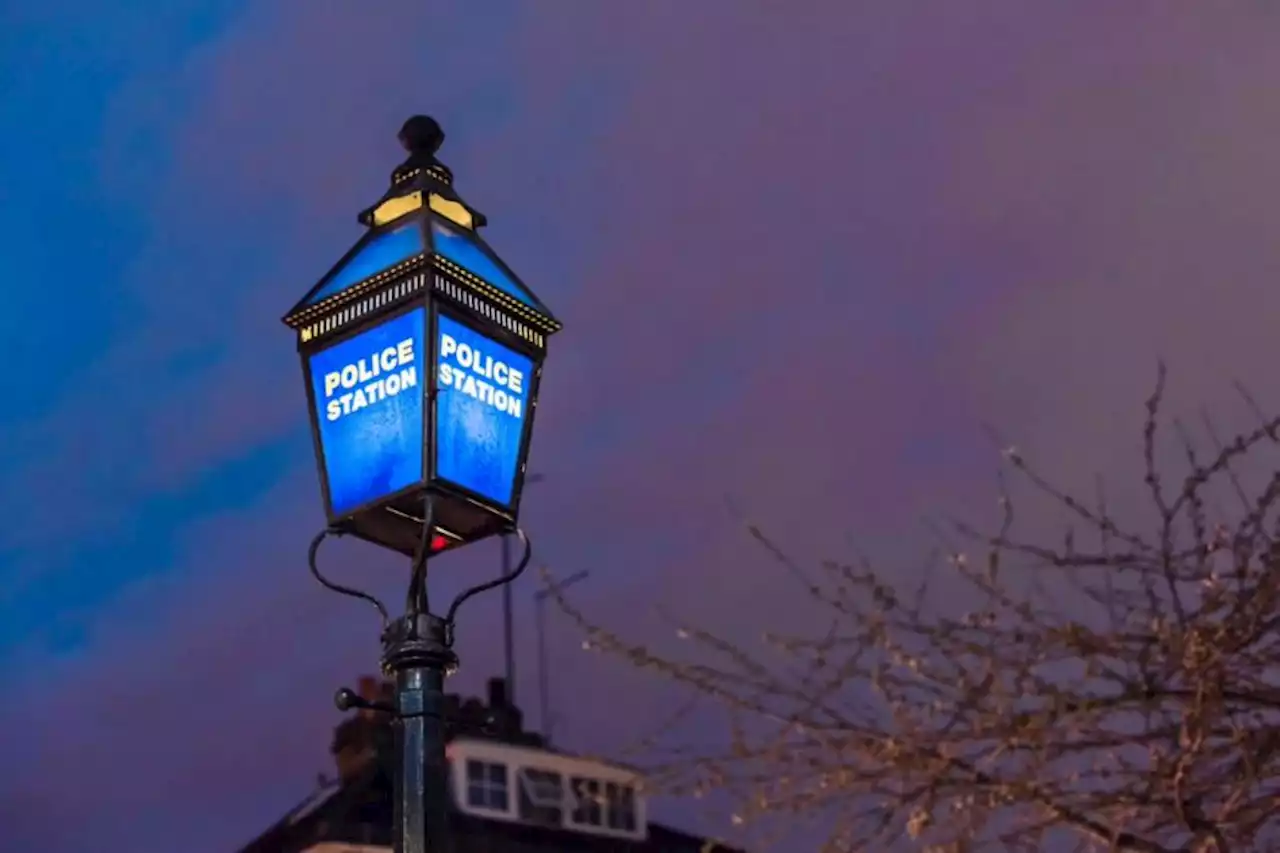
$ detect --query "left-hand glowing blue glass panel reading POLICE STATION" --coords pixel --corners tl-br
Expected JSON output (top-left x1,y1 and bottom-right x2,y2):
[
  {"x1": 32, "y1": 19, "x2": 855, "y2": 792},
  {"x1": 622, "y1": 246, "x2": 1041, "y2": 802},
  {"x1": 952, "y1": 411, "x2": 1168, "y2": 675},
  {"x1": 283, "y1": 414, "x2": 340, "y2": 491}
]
[{"x1": 308, "y1": 307, "x2": 426, "y2": 516}]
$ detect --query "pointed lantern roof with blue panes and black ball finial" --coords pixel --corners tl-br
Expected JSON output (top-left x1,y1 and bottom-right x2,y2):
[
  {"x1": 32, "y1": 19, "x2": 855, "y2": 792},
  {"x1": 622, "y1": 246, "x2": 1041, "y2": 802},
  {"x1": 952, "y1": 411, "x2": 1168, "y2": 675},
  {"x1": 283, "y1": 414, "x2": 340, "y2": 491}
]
[{"x1": 284, "y1": 115, "x2": 561, "y2": 332}]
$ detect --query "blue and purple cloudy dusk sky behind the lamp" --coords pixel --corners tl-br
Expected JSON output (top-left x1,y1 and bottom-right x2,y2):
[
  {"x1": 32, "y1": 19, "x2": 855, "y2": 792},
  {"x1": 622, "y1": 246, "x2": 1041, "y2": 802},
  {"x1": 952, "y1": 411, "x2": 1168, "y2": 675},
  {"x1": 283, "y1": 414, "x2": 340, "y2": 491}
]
[{"x1": 0, "y1": 0, "x2": 1280, "y2": 853}]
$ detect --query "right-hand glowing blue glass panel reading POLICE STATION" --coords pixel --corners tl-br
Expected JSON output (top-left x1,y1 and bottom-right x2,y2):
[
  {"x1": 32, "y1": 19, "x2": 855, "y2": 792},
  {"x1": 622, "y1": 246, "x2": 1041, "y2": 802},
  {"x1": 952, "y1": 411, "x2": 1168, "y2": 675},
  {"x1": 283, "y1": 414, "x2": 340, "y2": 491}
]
[{"x1": 435, "y1": 314, "x2": 534, "y2": 506}]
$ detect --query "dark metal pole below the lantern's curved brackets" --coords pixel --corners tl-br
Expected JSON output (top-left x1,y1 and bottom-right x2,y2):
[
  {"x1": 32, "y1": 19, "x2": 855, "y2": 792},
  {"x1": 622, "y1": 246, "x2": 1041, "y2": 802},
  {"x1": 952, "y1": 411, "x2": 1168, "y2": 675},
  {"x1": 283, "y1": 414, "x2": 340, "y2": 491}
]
[{"x1": 383, "y1": 613, "x2": 458, "y2": 853}]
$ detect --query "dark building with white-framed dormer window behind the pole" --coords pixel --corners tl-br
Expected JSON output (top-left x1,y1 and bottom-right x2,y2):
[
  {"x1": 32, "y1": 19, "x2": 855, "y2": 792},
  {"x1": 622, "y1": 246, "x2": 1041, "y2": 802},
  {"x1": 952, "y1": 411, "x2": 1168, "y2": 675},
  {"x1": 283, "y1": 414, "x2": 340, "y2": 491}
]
[{"x1": 239, "y1": 679, "x2": 740, "y2": 853}]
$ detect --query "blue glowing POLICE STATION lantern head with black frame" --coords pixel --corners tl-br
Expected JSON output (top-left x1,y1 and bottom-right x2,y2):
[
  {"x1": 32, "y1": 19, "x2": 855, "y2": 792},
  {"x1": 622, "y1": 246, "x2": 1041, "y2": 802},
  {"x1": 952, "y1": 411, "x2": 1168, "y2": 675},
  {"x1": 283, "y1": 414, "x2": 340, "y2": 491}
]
[{"x1": 284, "y1": 115, "x2": 561, "y2": 555}]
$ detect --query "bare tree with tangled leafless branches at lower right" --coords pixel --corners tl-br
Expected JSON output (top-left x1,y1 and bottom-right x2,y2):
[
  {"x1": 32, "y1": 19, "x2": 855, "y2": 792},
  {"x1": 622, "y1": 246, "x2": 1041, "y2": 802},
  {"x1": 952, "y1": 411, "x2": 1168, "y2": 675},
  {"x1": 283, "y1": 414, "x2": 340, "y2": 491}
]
[{"x1": 553, "y1": 365, "x2": 1280, "y2": 853}]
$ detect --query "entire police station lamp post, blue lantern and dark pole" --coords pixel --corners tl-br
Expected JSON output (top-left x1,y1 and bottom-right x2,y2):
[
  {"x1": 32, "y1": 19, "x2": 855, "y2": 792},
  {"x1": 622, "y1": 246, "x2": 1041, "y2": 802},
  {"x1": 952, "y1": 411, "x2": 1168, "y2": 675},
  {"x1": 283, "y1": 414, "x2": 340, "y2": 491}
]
[{"x1": 284, "y1": 115, "x2": 561, "y2": 853}]
